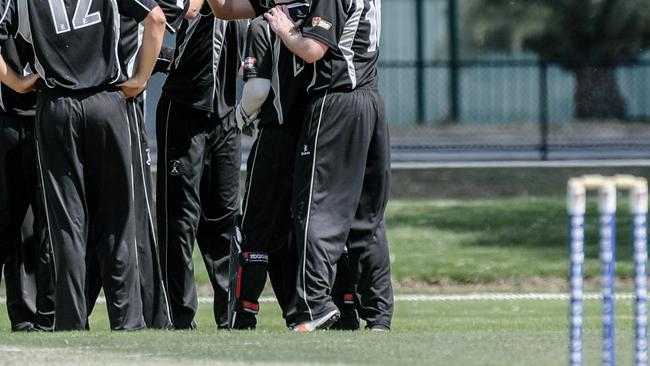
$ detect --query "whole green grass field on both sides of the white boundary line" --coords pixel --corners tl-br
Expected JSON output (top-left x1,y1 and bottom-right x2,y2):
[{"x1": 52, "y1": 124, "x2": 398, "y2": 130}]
[{"x1": 0, "y1": 196, "x2": 644, "y2": 365}]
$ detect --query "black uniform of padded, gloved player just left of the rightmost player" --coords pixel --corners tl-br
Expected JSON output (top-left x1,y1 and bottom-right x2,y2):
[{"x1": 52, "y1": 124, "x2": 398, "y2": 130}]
[{"x1": 231, "y1": 13, "x2": 309, "y2": 329}]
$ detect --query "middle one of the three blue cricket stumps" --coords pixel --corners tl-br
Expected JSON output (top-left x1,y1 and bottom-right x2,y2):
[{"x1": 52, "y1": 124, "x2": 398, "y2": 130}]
[{"x1": 598, "y1": 180, "x2": 616, "y2": 366}]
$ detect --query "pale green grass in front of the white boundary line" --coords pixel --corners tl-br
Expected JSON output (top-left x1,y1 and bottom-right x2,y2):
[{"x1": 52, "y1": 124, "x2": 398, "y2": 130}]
[{"x1": 0, "y1": 301, "x2": 632, "y2": 366}]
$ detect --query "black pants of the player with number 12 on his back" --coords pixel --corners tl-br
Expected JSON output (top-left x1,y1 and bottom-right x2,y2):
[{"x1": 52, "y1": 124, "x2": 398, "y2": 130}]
[{"x1": 36, "y1": 88, "x2": 145, "y2": 330}]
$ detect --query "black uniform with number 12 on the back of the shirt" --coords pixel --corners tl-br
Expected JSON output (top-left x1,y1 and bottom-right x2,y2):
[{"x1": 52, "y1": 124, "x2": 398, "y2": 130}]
[{"x1": 0, "y1": 0, "x2": 161, "y2": 330}]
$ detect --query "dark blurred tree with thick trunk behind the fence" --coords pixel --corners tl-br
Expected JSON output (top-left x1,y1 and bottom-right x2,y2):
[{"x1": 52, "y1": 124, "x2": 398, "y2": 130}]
[{"x1": 461, "y1": 0, "x2": 650, "y2": 119}]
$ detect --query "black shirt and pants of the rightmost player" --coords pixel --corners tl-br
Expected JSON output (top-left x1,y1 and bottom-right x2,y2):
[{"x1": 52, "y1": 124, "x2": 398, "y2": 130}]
[{"x1": 292, "y1": 0, "x2": 393, "y2": 328}]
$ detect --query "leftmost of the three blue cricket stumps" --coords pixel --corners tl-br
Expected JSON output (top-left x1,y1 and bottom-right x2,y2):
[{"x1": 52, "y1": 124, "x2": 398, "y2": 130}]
[{"x1": 567, "y1": 179, "x2": 587, "y2": 366}]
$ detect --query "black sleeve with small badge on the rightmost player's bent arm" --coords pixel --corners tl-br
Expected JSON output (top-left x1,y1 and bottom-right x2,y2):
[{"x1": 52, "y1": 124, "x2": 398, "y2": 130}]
[{"x1": 302, "y1": 0, "x2": 346, "y2": 48}]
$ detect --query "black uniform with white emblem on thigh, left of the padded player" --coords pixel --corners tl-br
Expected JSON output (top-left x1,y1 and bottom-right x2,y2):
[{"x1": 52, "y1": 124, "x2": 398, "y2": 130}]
[{"x1": 156, "y1": 6, "x2": 244, "y2": 329}]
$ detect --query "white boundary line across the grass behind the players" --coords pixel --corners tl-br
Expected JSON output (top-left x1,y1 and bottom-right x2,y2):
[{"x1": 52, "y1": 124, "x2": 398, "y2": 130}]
[{"x1": 0, "y1": 293, "x2": 634, "y2": 304}]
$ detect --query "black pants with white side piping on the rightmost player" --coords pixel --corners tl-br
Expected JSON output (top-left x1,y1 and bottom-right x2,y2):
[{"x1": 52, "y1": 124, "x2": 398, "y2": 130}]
[{"x1": 293, "y1": 90, "x2": 393, "y2": 321}]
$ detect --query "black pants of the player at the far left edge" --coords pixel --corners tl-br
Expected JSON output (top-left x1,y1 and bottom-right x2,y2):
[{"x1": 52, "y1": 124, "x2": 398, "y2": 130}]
[{"x1": 0, "y1": 114, "x2": 54, "y2": 330}]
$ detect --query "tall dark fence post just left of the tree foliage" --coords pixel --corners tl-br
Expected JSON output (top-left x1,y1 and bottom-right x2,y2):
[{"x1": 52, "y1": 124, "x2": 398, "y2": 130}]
[{"x1": 447, "y1": 0, "x2": 460, "y2": 121}]
